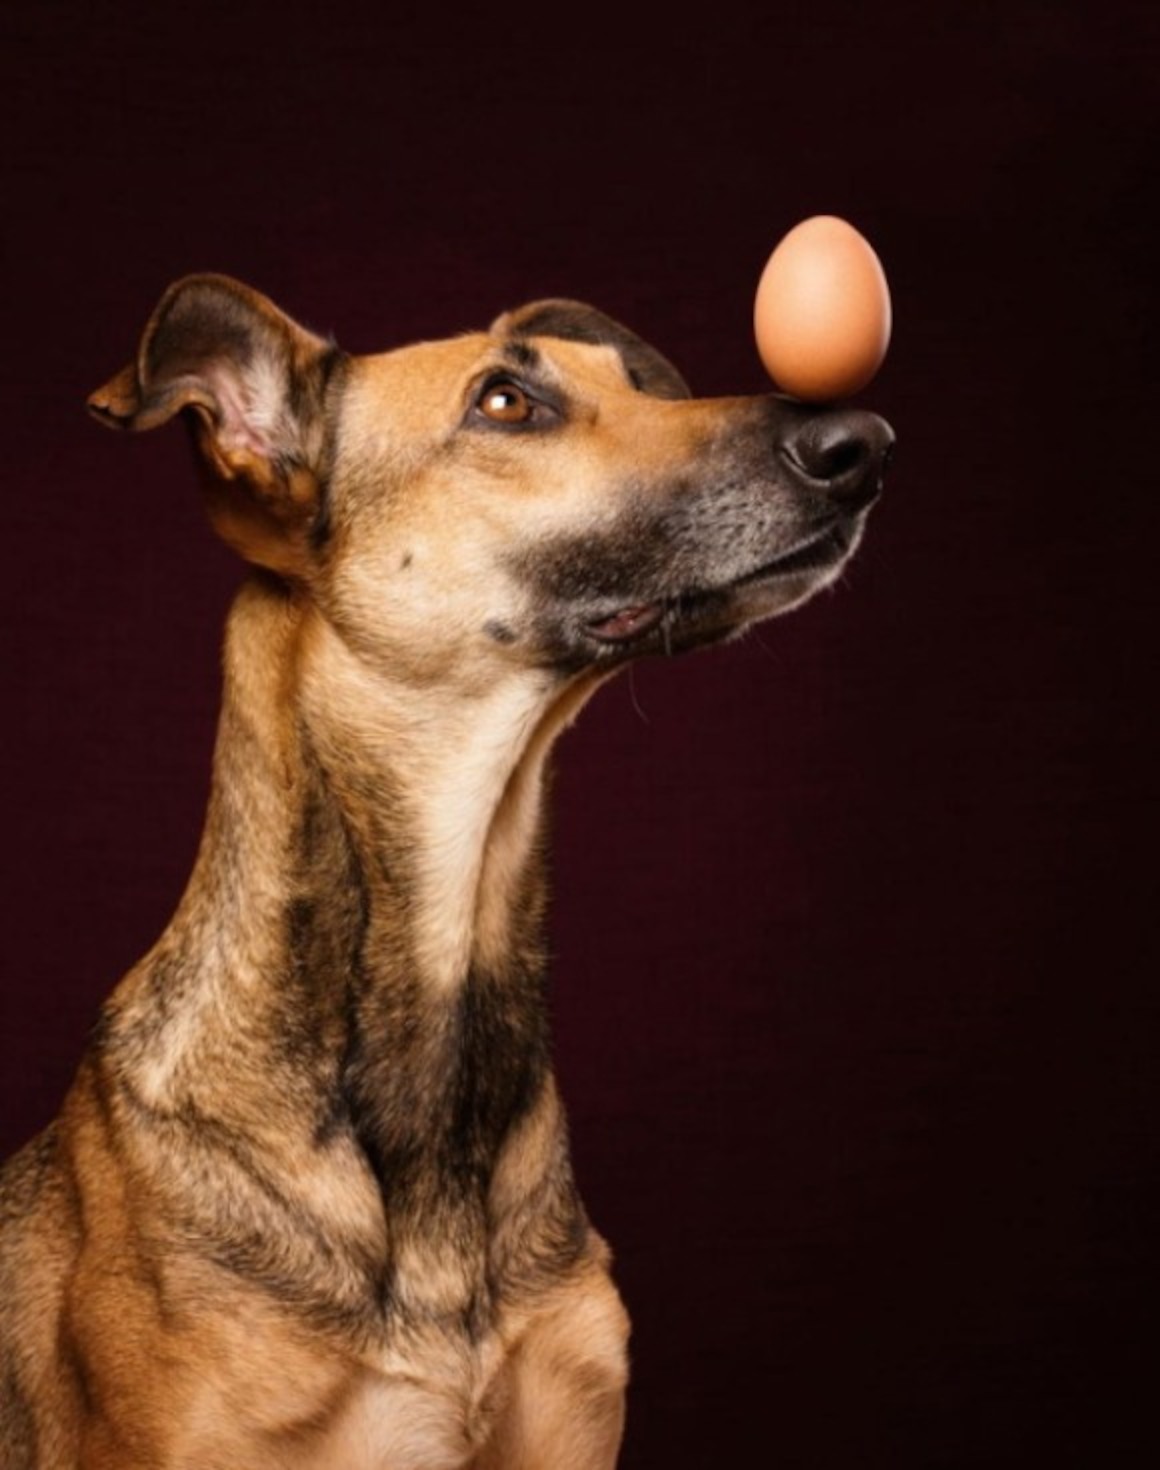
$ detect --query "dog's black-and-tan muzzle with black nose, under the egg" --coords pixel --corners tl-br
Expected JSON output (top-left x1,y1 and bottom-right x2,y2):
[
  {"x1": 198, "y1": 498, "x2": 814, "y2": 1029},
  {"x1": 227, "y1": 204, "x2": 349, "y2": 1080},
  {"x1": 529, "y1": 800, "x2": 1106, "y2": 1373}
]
[{"x1": 520, "y1": 394, "x2": 894, "y2": 667}]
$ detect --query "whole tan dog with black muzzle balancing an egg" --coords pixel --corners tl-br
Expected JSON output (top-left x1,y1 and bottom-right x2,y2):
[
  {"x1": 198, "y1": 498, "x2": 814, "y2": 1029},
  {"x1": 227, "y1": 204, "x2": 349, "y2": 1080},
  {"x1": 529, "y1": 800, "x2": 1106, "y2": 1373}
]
[{"x1": 0, "y1": 275, "x2": 892, "y2": 1470}]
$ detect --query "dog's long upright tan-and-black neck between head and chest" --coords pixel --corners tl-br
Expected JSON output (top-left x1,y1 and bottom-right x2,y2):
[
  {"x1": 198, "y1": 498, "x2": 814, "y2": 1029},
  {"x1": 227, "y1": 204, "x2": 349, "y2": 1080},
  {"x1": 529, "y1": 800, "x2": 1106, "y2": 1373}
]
[{"x1": 102, "y1": 581, "x2": 591, "y2": 1217}]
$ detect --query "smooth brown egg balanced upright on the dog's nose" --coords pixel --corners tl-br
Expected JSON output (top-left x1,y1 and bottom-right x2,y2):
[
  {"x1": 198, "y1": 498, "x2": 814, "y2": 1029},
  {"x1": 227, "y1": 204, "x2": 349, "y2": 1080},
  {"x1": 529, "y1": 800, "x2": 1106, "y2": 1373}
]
[{"x1": 753, "y1": 215, "x2": 891, "y2": 403}]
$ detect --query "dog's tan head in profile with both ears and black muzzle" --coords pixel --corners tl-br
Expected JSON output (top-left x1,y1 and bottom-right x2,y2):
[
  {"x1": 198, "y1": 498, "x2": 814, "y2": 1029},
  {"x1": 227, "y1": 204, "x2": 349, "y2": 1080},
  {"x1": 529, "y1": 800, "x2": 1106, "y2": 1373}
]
[{"x1": 90, "y1": 276, "x2": 892, "y2": 678}]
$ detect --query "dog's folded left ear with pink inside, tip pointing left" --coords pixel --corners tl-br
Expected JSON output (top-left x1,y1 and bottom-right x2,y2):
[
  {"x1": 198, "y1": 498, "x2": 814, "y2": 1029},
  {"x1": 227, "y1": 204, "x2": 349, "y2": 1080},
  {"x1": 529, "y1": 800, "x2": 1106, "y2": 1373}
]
[{"x1": 88, "y1": 275, "x2": 343, "y2": 575}]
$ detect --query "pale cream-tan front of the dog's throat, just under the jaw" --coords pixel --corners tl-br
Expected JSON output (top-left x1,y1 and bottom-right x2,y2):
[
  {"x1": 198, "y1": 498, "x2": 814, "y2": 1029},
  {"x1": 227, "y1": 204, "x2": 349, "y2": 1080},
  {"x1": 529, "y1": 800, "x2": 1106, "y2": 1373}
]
[{"x1": 300, "y1": 602, "x2": 554, "y2": 995}]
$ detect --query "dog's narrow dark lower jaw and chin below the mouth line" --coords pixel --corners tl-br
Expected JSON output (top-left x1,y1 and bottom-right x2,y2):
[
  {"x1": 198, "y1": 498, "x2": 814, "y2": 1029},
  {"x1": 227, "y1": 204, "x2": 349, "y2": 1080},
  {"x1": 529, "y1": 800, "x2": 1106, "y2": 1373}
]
[{"x1": 569, "y1": 517, "x2": 862, "y2": 662}]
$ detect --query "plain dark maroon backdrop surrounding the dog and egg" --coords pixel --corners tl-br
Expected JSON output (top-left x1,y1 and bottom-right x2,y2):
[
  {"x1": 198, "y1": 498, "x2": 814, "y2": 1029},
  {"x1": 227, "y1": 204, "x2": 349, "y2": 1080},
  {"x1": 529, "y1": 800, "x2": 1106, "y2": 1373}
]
[{"x1": 0, "y1": 0, "x2": 1160, "y2": 1470}]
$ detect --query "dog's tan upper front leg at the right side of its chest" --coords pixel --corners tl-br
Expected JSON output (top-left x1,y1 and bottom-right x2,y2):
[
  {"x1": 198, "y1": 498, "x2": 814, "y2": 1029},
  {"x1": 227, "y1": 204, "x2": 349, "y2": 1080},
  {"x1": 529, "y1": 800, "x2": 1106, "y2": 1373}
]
[{"x1": 472, "y1": 1267, "x2": 628, "y2": 1470}]
